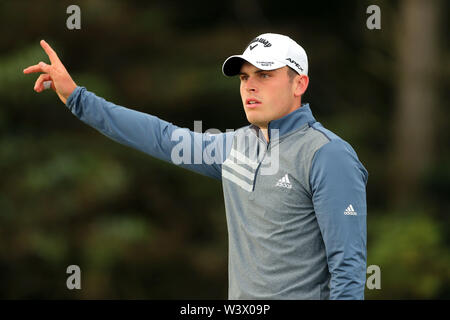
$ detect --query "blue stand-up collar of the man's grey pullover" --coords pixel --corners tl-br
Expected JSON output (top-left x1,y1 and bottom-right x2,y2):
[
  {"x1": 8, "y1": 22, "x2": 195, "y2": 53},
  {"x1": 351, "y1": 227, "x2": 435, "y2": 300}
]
[{"x1": 251, "y1": 103, "x2": 316, "y2": 138}]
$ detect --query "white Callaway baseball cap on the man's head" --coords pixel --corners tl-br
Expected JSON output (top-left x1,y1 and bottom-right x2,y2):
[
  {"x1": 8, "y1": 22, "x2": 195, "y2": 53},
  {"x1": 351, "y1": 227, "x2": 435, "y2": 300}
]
[{"x1": 222, "y1": 33, "x2": 308, "y2": 77}]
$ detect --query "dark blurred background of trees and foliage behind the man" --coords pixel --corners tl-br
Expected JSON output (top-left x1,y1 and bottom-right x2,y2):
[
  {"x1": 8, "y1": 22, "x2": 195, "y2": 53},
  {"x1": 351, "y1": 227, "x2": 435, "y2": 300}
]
[{"x1": 0, "y1": 0, "x2": 450, "y2": 299}]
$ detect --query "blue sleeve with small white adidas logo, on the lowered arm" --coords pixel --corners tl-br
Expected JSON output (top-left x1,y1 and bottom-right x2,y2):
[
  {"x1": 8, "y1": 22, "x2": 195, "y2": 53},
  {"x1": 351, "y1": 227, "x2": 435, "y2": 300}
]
[{"x1": 310, "y1": 140, "x2": 368, "y2": 299}]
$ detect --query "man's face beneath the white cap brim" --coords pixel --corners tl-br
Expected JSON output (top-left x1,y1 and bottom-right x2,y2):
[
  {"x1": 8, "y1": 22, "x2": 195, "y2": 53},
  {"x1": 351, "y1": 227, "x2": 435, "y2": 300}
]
[{"x1": 239, "y1": 62, "x2": 300, "y2": 129}]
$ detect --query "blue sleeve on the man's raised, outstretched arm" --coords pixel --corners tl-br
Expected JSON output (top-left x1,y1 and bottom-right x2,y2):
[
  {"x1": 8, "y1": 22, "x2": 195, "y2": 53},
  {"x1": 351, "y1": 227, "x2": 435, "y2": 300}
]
[{"x1": 66, "y1": 87, "x2": 234, "y2": 179}]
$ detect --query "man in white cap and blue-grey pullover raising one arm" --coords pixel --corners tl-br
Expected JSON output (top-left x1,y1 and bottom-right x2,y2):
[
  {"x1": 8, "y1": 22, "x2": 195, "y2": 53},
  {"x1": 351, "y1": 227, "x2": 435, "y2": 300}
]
[{"x1": 24, "y1": 33, "x2": 368, "y2": 299}]
